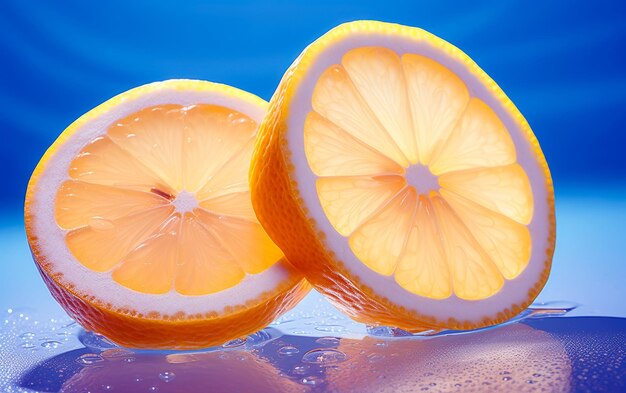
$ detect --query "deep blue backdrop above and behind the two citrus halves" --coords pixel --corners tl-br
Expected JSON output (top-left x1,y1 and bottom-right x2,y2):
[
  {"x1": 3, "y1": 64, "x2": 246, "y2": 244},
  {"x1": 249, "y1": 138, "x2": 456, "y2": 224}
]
[{"x1": 0, "y1": 0, "x2": 626, "y2": 215}]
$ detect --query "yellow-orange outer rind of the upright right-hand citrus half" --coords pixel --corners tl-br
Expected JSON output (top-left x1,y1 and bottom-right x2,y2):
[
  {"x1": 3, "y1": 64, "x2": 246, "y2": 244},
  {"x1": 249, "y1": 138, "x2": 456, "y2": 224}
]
[{"x1": 250, "y1": 21, "x2": 556, "y2": 331}]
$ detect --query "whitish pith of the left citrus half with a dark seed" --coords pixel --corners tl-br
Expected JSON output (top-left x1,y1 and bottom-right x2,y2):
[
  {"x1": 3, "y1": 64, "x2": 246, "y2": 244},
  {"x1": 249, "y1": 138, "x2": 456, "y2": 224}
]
[{"x1": 31, "y1": 81, "x2": 293, "y2": 315}]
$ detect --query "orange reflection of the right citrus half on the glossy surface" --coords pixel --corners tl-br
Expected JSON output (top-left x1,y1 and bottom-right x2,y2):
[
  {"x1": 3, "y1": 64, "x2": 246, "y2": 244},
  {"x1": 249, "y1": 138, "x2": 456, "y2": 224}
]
[{"x1": 327, "y1": 323, "x2": 572, "y2": 392}]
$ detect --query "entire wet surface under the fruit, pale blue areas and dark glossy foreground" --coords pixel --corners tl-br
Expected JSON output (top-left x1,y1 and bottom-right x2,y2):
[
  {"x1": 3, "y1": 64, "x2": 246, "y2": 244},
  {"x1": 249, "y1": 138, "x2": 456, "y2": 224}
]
[{"x1": 0, "y1": 189, "x2": 626, "y2": 392}]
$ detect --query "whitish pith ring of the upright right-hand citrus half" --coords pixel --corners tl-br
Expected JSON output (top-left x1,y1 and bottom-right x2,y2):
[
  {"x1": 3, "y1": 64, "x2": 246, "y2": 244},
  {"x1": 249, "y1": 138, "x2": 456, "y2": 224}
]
[{"x1": 286, "y1": 32, "x2": 550, "y2": 323}]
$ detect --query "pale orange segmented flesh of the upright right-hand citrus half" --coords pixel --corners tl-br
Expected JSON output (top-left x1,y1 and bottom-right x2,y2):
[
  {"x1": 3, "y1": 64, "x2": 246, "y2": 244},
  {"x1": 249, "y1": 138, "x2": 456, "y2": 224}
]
[{"x1": 304, "y1": 47, "x2": 533, "y2": 300}]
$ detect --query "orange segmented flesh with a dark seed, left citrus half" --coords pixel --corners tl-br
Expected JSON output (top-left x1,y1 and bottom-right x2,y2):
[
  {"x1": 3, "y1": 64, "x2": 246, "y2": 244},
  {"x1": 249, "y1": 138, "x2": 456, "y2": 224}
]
[{"x1": 55, "y1": 104, "x2": 282, "y2": 296}]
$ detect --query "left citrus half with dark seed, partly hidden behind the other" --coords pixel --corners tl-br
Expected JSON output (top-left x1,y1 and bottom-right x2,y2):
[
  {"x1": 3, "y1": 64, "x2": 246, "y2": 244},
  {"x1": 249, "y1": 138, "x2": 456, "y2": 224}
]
[{"x1": 25, "y1": 80, "x2": 309, "y2": 349}]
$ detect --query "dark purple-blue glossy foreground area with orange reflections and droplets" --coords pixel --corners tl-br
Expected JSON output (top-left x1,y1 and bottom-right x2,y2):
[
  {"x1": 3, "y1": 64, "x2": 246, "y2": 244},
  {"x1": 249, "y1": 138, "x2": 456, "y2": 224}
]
[{"x1": 18, "y1": 317, "x2": 626, "y2": 392}]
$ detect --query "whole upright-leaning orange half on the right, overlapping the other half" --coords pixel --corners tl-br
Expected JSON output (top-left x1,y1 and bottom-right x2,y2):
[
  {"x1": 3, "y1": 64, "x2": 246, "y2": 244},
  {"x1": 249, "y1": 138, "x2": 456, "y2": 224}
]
[{"x1": 250, "y1": 21, "x2": 555, "y2": 331}]
